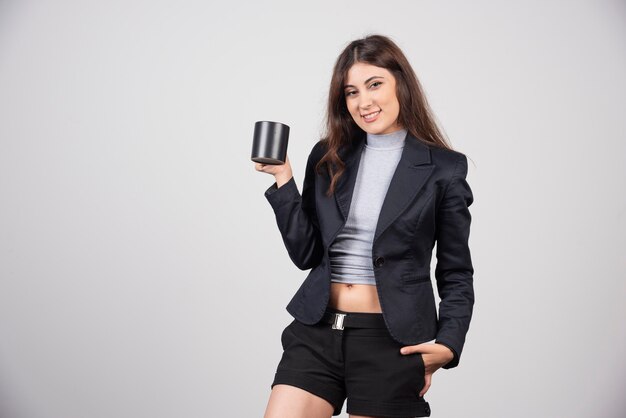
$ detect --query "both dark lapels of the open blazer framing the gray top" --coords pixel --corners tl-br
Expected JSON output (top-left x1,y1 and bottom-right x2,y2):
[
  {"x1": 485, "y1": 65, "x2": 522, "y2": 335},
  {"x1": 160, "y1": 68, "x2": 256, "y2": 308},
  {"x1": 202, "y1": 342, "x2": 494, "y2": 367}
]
[{"x1": 335, "y1": 134, "x2": 434, "y2": 241}]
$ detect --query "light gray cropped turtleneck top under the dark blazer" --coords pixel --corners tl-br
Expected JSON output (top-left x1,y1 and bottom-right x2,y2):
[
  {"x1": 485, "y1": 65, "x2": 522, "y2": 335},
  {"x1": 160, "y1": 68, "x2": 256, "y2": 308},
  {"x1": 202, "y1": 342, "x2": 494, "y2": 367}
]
[{"x1": 329, "y1": 129, "x2": 407, "y2": 285}]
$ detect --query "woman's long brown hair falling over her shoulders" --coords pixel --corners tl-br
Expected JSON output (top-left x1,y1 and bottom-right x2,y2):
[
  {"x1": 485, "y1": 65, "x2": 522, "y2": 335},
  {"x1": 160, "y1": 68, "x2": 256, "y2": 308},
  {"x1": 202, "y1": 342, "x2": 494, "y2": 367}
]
[{"x1": 315, "y1": 35, "x2": 452, "y2": 196}]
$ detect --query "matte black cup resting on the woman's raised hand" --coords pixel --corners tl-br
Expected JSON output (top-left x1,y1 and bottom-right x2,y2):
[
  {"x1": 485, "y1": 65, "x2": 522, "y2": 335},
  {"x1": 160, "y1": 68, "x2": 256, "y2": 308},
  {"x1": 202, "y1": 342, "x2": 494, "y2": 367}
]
[{"x1": 251, "y1": 120, "x2": 289, "y2": 165}]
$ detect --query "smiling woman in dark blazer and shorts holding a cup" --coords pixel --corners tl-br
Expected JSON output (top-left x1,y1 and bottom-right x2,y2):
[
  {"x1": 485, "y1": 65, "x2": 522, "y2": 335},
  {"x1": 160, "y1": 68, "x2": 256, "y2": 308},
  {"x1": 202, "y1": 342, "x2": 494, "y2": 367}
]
[{"x1": 256, "y1": 35, "x2": 474, "y2": 418}]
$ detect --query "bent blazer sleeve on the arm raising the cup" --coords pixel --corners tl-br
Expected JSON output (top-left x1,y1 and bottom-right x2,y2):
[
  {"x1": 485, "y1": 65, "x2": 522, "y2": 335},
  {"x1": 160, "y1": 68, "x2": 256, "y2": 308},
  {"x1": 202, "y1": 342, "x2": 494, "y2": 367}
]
[{"x1": 265, "y1": 147, "x2": 324, "y2": 270}]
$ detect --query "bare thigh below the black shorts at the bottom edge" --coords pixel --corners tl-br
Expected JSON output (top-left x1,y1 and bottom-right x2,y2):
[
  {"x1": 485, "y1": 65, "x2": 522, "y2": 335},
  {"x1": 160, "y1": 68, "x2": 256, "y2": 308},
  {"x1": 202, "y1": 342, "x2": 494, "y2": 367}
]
[{"x1": 264, "y1": 384, "x2": 335, "y2": 418}]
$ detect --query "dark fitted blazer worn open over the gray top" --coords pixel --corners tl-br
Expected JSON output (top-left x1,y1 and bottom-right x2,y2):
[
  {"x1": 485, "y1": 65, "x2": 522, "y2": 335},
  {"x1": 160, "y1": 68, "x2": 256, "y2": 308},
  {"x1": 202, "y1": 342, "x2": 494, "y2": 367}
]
[{"x1": 265, "y1": 134, "x2": 474, "y2": 368}]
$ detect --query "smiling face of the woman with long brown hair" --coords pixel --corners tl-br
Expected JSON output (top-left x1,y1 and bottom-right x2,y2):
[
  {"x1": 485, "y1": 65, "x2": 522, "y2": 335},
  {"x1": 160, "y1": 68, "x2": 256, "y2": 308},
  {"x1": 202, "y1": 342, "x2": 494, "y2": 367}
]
[{"x1": 344, "y1": 62, "x2": 402, "y2": 134}]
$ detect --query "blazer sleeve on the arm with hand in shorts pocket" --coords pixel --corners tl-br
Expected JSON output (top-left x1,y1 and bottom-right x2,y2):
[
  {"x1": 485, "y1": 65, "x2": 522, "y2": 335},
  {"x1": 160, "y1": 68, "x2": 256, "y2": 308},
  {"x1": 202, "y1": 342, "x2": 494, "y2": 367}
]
[{"x1": 435, "y1": 155, "x2": 474, "y2": 369}]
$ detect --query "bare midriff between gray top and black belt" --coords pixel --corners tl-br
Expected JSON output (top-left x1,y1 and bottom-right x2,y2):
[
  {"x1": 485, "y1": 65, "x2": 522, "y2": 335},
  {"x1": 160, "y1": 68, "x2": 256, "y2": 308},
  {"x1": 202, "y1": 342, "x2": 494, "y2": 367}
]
[{"x1": 328, "y1": 282, "x2": 382, "y2": 313}]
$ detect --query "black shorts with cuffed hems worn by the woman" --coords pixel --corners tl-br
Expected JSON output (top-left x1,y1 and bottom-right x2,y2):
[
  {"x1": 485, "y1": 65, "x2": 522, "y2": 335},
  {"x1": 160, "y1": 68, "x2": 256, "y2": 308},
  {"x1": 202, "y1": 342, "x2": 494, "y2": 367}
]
[{"x1": 271, "y1": 307, "x2": 430, "y2": 418}]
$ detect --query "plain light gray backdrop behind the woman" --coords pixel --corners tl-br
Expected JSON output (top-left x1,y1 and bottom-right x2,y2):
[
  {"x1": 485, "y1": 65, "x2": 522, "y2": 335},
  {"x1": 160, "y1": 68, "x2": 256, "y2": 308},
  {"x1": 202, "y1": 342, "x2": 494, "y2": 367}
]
[{"x1": 0, "y1": 0, "x2": 626, "y2": 418}]
